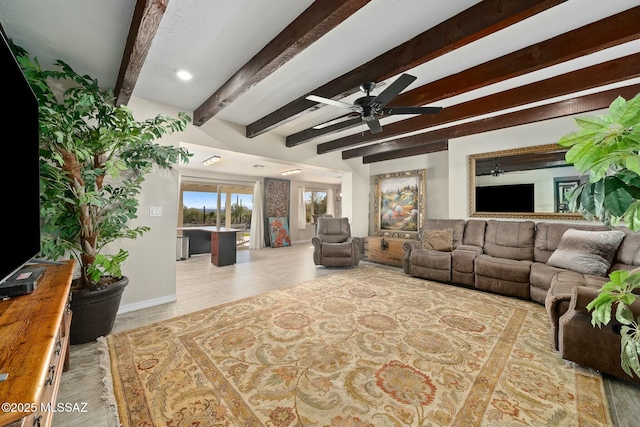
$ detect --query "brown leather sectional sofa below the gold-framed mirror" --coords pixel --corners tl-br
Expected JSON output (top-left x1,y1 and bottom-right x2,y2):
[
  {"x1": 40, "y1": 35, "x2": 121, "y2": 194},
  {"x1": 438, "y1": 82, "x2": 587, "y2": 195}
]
[{"x1": 403, "y1": 219, "x2": 640, "y2": 382}]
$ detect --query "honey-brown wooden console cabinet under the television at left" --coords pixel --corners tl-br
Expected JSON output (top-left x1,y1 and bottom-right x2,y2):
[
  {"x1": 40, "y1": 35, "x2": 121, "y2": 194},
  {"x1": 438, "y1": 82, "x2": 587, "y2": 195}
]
[{"x1": 0, "y1": 261, "x2": 74, "y2": 427}]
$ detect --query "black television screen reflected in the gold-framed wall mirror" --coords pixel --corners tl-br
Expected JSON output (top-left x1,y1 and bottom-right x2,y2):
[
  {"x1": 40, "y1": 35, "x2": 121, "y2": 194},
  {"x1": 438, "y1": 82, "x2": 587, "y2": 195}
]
[{"x1": 476, "y1": 184, "x2": 534, "y2": 212}]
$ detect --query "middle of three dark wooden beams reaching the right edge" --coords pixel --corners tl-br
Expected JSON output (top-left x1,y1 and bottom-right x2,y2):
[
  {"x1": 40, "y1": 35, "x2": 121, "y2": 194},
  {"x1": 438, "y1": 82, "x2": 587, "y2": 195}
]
[{"x1": 317, "y1": 53, "x2": 640, "y2": 154}]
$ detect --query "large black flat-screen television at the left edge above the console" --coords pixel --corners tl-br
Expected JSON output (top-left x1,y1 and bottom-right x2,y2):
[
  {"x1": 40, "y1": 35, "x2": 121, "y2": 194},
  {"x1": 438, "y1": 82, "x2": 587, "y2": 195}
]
[{"x1": 0, "y1": 31, "x2": 40, "y2": 284}]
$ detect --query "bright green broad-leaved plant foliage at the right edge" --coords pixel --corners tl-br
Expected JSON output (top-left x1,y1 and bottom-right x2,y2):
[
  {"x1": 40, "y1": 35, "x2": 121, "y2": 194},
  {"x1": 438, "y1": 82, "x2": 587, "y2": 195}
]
[{"x1": 559, "y1": 94, "x2": 640, "y2": 377}]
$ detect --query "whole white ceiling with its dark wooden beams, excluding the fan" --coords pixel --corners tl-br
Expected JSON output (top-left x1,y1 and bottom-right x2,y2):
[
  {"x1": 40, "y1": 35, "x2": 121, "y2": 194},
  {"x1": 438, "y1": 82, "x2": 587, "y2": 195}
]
[{"x1": 0, "y1": 0, "x2": 640, "y2": 174}]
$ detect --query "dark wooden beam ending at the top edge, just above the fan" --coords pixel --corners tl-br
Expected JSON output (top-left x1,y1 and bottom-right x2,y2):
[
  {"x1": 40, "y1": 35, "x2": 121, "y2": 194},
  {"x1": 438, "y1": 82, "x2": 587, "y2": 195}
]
[{"x1": 246, "y1": 0, "x2": 566, "y2": 138}]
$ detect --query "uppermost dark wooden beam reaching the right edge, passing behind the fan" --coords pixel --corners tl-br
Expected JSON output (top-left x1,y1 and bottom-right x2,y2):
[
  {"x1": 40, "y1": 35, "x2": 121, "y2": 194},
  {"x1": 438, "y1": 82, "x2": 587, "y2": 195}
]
[{"x1": 286, "y1": 6, "x2": 640, "y2": 147}]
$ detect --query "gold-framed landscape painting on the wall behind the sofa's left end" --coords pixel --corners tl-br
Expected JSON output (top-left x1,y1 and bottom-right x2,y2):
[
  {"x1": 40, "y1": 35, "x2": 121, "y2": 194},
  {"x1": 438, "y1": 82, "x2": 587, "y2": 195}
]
[{"x1": 373, "y1": 169, "x2": 426, "y2": 239}]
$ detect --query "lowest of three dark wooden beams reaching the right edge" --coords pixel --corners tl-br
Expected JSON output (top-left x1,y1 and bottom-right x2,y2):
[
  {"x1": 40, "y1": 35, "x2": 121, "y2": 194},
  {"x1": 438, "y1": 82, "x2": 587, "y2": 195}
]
[{"x1": 360, "y1": 84, "x2": 640, "y2": 163}]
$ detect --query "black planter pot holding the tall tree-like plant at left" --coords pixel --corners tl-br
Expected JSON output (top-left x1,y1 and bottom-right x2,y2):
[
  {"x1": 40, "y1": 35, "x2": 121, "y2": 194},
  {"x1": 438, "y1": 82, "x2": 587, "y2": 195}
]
[{"x1": 69, "y1": 276, "x2": 129, "y2": 345}]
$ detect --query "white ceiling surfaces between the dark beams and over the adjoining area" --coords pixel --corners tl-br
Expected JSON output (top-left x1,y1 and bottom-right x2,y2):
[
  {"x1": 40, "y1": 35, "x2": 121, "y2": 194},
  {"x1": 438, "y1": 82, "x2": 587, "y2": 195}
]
[{"x1": 0, "y1": 0, "x2": 640, "y2": 183}]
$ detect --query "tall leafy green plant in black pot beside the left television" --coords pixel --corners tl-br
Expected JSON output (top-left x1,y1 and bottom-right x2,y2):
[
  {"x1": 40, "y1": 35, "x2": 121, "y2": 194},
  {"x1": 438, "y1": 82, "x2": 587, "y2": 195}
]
[{"x1": 12, "y1": 44, "x2": 190, "y2": 344}]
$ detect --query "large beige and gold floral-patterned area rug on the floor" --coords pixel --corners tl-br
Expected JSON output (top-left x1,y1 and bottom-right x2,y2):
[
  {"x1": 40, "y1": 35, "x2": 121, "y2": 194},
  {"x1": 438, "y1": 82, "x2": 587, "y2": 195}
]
[{"x1": 108, "y1": 267, "x2": 611, "y2": 427}]
